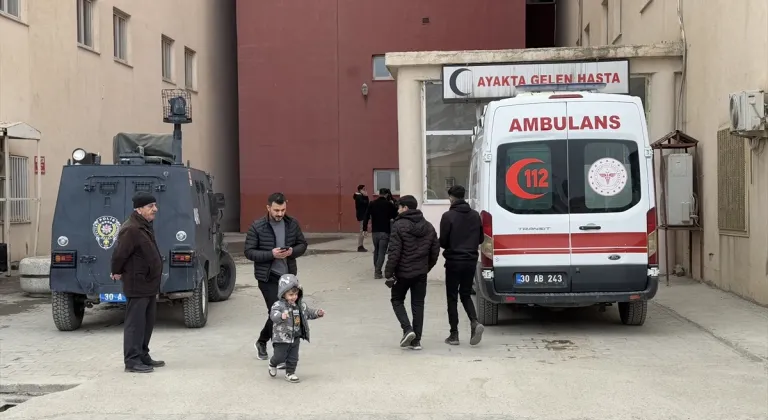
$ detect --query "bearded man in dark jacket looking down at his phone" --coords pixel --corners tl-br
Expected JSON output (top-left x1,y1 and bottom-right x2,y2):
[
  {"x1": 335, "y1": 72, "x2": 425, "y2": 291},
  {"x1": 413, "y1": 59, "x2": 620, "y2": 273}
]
[{"x1": 244, "y1": 193, "x2": 307, "y2": 360}]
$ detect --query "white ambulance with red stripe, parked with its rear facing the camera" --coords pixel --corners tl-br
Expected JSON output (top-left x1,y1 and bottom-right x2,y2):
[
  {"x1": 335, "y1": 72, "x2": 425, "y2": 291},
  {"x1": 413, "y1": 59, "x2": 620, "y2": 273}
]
[{"x1": 468, "y1": 84, "x2": 659, "y2": 325}]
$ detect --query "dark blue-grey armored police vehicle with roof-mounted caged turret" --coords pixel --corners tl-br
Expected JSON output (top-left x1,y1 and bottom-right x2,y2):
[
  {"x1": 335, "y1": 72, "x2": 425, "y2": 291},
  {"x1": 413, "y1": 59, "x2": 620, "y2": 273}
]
[{"x1": 50, "y1": 91, "x2": 235, "y2": 331}]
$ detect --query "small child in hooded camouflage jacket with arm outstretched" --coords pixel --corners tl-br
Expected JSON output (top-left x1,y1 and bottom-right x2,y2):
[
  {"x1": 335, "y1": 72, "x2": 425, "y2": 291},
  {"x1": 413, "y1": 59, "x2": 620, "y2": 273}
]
[{"x1": 269, "y1": 274, "x2": 325, "y2": 382}]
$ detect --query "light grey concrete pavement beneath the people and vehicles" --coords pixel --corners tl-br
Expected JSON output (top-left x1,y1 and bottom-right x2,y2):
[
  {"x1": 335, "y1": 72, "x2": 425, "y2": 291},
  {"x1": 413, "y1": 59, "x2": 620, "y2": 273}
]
[{"x1": 0, "y1": 239, "x2": 768, "y2": 420}]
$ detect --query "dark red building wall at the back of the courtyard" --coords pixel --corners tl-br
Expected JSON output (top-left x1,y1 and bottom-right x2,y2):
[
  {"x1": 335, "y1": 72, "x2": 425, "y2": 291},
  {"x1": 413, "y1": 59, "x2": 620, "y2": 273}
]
[{"x1": 237, "y1": 0, "x2": 525, "y2": 232}]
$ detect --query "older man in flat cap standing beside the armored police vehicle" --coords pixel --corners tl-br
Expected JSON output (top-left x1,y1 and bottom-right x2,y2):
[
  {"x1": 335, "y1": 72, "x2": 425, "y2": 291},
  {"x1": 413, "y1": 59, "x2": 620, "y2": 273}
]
[{"x1": 111, "y1": 192, "x2": 165, "y2": 373}]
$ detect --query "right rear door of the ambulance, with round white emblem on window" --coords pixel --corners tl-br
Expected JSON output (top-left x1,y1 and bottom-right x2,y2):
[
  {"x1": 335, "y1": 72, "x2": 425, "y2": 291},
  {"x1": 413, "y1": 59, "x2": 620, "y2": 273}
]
[{"x1": 567, "y1": 99, "x2": 651, "y2": 292}]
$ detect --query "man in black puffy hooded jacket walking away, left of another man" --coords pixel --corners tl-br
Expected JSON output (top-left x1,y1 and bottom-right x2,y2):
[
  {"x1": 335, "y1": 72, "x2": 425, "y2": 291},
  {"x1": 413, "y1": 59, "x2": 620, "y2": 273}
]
[{"x1": 384, "y1": 195, "x2": 440, "y2": 350}]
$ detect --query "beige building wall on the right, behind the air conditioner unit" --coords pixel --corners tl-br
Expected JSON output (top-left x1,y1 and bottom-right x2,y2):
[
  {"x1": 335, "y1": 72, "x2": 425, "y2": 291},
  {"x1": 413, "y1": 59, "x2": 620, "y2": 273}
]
[{"x1": 558, "y1": 0, "x2": 768, "y2": 304}]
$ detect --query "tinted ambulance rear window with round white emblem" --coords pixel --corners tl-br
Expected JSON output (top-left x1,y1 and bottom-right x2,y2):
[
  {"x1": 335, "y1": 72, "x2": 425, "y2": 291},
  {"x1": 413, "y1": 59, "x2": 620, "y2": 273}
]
[{"x1": 568, "y1": 139, "x2": 642, "y2": 213}]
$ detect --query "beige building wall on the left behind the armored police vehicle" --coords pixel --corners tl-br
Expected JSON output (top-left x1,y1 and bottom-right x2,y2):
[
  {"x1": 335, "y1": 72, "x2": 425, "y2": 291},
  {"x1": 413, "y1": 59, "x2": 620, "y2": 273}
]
[{"x1": 0, "y1": 0, "x2": 239, "y2": 260}]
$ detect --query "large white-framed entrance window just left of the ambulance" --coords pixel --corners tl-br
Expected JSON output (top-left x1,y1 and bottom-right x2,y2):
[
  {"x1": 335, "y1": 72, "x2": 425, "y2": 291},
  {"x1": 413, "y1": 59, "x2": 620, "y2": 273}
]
[{"x1": 423, "y1": 82, "x2": 476, "y2": 202}]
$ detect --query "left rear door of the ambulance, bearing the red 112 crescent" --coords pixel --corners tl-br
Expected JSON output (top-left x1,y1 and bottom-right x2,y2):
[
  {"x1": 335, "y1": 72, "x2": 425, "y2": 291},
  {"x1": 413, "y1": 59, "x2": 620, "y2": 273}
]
[{"x1": 489, "y1": 97, "x2": 571, "y2": 293}]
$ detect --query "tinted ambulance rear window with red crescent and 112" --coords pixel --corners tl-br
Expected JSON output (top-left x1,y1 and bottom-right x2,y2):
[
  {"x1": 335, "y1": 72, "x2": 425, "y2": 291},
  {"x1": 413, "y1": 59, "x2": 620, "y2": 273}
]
[{"x1": 496, "y1": 140, "x2": 568, "y2": 214}]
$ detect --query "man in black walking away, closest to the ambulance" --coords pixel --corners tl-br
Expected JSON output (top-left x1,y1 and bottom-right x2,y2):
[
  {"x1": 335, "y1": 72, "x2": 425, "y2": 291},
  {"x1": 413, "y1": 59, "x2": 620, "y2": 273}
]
[{"x1": 440, "y1": 185, "x2": 483, "y2": 346}]
